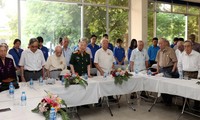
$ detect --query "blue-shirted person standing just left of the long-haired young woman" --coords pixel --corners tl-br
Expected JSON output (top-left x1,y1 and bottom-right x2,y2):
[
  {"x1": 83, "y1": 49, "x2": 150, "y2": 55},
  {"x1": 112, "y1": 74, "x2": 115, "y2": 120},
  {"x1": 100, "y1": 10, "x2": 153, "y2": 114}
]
[{"x1": 113, "y1": 39, "x2": 126, "y2": 65}]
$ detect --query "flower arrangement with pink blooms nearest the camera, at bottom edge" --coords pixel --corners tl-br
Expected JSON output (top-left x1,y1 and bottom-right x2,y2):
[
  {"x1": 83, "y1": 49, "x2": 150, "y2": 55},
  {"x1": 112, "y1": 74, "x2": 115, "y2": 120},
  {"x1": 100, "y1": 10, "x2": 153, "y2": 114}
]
[{"x1": 32, "y1": 91, "x2": 69, "y2": 120}]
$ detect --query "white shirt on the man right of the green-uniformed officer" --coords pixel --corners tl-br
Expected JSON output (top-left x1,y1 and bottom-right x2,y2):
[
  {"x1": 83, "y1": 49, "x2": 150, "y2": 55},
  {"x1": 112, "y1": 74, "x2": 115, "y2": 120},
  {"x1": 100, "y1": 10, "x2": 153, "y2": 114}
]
[{"x1": 94, "y1": 48, "x2": 115, "y2": 75}]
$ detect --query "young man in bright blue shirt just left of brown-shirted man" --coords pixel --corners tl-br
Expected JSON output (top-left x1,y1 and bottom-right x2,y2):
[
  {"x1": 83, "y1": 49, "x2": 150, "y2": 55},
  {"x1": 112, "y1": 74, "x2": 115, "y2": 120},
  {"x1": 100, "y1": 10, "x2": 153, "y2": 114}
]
[{"x1": 148, "y1": 37, "x2": 160, "y2": 67}]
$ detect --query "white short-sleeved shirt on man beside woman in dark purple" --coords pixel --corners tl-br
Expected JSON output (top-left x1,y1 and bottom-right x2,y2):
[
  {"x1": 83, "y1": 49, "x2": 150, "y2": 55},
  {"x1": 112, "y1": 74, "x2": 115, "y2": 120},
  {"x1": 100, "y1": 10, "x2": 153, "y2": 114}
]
[{"x1": 19, "y1": 49, "x2": 45, "y2": 71}]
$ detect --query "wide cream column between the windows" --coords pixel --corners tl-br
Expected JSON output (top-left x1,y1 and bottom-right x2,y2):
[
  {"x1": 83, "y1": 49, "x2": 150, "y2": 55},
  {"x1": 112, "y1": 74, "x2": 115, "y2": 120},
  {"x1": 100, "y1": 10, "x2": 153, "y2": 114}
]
[{"x1": 130, "y1": 0, "x2": 148, "y2": 44}]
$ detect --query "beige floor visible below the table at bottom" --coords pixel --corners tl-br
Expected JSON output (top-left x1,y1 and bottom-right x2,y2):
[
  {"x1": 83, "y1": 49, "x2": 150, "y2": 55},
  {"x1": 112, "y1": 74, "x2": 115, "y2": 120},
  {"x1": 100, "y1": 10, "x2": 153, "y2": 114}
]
[{"x1": 73, "y1": 96, "x2": 200, "y2": 120}]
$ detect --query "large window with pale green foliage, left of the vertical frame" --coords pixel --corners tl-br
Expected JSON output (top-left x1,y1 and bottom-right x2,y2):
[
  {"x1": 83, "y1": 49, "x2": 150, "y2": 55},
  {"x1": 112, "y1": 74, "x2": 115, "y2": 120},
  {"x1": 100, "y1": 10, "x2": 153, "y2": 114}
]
[{"x1": 21, "y1": 1, "x2": 81, "y2": 47}]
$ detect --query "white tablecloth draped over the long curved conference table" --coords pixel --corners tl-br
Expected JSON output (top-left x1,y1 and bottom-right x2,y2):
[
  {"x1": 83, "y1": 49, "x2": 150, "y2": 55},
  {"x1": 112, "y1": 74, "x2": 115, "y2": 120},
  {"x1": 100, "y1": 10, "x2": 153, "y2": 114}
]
[{"x1": 0, "y1": 74, "x2": 200, "y2": 120}]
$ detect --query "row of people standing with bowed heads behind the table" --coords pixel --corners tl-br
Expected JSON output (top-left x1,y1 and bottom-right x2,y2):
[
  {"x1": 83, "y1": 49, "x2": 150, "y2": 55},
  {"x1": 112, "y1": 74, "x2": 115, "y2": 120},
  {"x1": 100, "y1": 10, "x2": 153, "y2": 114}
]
[{"x1": 0, "y1": 34, "x2": 200, "y2": 109}]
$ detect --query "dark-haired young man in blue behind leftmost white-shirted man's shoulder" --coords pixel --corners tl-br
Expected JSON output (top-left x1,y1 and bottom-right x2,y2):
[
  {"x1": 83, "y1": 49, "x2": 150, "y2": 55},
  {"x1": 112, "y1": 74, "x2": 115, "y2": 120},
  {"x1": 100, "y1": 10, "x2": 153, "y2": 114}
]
[{"x1": 37, "y1": 36, "x2": 49, "y2": 61}]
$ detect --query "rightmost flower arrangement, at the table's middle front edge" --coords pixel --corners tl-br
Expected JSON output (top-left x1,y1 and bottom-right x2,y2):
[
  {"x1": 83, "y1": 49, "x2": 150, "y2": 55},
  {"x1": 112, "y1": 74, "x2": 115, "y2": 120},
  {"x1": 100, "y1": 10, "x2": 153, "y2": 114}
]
[{"x1": 112, "y1": 68, "x2": 132, "y2": 85}]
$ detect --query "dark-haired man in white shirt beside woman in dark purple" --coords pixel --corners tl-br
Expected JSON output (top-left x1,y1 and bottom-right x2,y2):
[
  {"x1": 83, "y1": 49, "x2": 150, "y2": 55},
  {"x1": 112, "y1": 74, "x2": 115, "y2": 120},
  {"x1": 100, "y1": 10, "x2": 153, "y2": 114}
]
[{"x1": 19, "y1": 38, "x2": 45, "y2": 82}]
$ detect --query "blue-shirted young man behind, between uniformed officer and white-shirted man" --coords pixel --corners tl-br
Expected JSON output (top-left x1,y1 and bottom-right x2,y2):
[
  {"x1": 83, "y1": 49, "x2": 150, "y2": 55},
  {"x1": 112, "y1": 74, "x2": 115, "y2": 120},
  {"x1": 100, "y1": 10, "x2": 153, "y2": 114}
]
[{"x1": 88, "y1": 35, "x2": 99, "y2": 68}]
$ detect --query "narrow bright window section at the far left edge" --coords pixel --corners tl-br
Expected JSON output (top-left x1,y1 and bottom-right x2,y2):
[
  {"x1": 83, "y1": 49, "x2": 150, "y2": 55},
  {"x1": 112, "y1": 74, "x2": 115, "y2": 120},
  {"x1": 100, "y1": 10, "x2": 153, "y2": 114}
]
[{"x1": 0, "y1": 0, "x2": 18, "y2": 47}]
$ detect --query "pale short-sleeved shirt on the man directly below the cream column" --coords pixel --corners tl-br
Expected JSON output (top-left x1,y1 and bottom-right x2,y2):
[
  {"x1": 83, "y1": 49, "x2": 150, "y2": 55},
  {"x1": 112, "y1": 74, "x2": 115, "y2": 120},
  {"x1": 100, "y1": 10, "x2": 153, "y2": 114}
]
[{"x1": 130, "y1": 48, "x2": 149, "y2": 71}]
